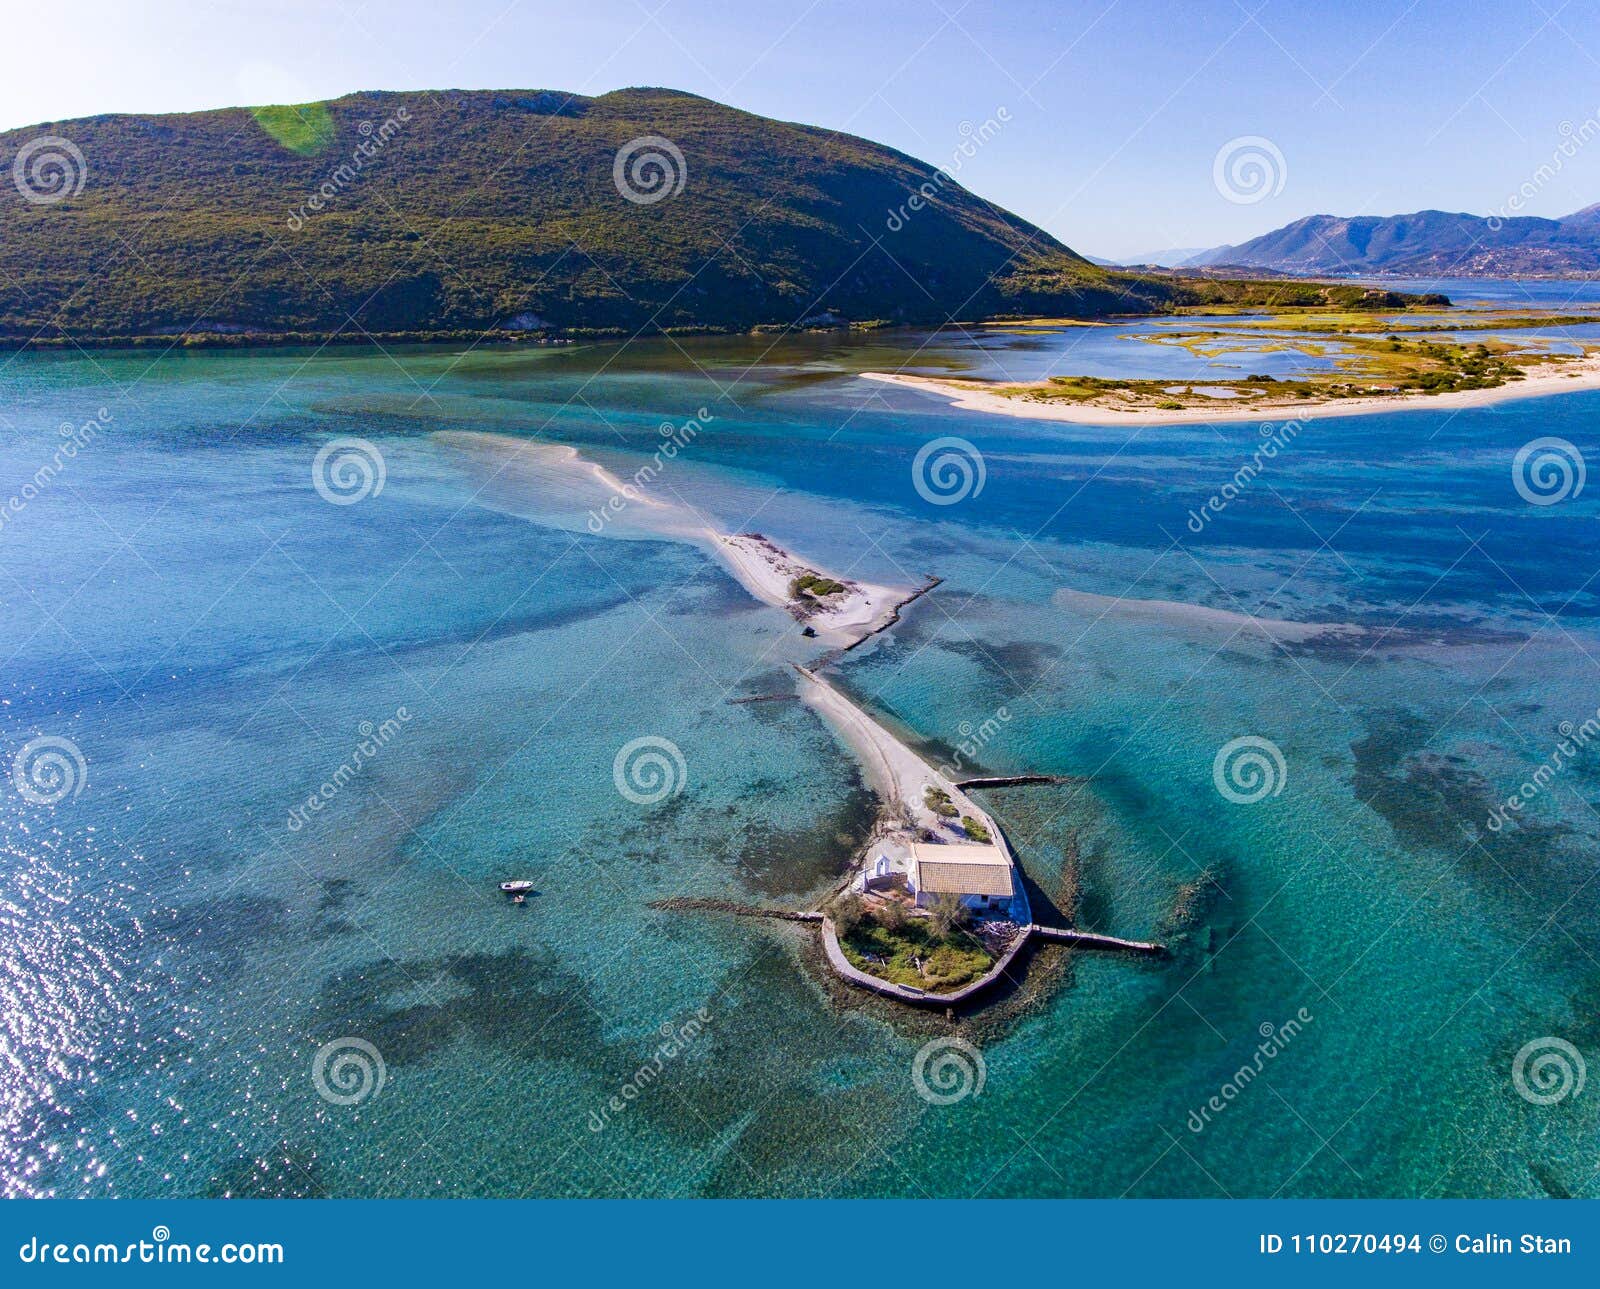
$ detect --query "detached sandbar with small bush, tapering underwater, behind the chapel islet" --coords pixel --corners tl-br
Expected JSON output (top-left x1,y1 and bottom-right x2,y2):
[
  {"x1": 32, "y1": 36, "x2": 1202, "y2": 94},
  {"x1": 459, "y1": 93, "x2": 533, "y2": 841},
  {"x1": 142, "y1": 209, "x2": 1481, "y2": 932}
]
[{"x1": 435, "y1": 430, "x2": 920, "y2": 648}]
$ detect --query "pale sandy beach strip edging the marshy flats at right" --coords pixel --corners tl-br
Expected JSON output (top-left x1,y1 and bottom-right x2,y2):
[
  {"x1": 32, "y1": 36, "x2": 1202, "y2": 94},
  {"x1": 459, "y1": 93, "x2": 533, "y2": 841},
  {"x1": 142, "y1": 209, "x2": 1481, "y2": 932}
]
[{"x1": 859, "y1": 357, "x2": 1600, "y2": 425}]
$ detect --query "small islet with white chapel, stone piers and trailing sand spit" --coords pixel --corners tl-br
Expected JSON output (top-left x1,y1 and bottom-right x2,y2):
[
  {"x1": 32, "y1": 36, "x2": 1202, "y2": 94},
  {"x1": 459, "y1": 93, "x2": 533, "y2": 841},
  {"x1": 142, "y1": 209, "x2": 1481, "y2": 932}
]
[{"x1": 438, "y1": 432, "x2": 1162, "y2": 1006}]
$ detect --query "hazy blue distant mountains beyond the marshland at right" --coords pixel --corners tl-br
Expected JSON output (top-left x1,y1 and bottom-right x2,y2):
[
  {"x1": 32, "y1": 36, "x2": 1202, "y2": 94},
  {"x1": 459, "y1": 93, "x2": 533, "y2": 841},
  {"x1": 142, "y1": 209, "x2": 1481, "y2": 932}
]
[{"x1": 1178, "y1": 205, "x2": 1600, "y2": 278}]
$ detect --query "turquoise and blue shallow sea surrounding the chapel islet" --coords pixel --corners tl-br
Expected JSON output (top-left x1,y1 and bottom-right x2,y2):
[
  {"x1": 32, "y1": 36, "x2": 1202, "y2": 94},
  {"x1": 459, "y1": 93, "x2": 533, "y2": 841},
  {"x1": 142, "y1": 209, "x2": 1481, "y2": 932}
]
[{"x1": 0, "y1": 310, "x2": 1600, "y2": 1196}]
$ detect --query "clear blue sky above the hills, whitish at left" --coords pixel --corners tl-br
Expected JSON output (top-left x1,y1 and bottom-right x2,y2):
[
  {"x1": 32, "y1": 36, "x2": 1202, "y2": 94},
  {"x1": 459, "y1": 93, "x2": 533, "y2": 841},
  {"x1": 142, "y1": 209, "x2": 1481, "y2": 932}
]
[{"x1": 9, "y1": 0, "x2": 1600, "y2": 256}]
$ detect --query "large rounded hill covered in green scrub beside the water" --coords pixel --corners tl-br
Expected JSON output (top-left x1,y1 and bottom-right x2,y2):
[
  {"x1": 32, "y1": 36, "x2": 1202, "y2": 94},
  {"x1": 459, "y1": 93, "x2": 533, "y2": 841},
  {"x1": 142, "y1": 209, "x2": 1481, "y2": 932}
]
[{"x1": 0, "y1": 90, "x2": 1184, "y2": 342}]
